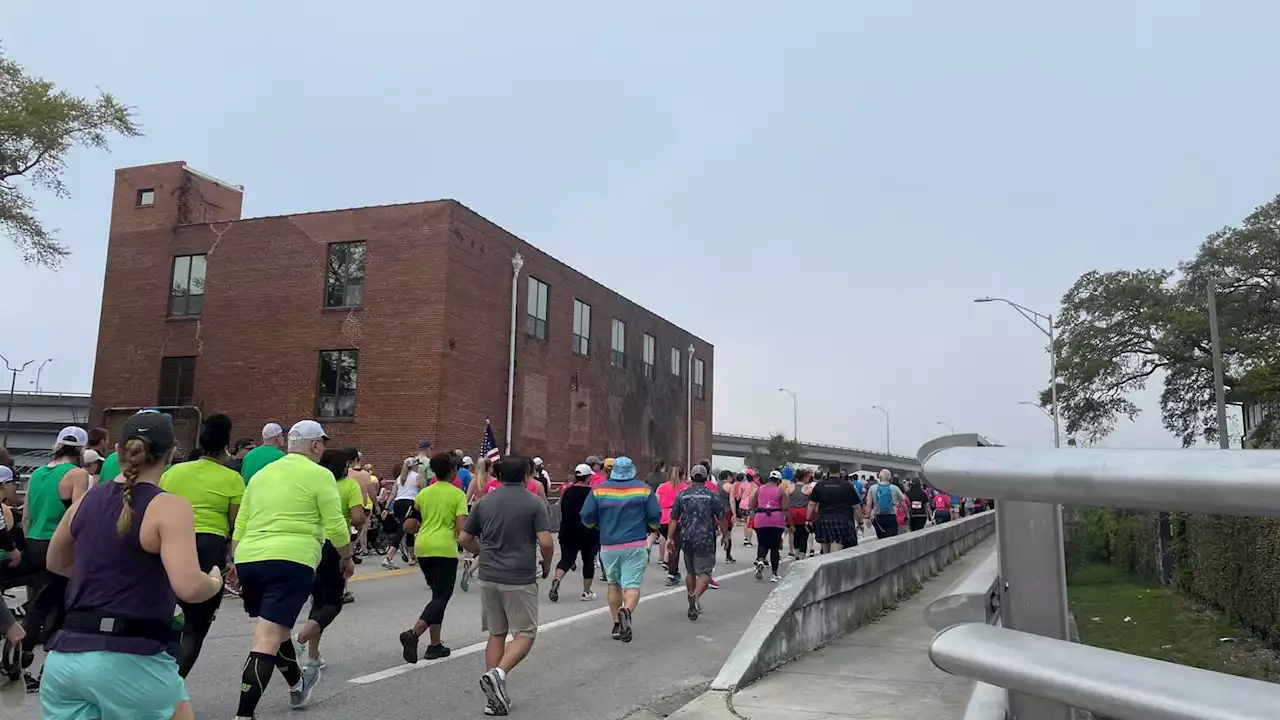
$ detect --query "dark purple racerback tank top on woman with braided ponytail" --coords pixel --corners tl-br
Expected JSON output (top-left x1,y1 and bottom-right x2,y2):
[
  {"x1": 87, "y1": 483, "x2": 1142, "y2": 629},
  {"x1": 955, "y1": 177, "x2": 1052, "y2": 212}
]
[{"x1": 49, "y1": 483, "x2": 178, "y2": 655}]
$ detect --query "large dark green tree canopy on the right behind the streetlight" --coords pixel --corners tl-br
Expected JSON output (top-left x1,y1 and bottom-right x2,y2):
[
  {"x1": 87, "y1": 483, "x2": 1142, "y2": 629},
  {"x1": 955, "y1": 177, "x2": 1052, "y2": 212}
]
[{"x1": 1041, "y1": 197, "x2": 1280, "y2": 447}]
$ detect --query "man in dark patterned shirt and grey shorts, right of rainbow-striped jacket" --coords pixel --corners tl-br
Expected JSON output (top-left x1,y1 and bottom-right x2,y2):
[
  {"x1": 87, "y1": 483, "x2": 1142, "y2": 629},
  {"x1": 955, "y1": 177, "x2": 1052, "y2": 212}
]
[{"x1": 667, "y1": 465, "x2": 733, "y2": 621}]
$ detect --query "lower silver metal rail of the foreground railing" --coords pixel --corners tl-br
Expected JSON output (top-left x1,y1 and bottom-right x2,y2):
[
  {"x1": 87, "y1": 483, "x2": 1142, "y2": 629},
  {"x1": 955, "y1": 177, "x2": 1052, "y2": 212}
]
[{"x1": 929, "y1": 622, "x2": 1280, "y2": 720}]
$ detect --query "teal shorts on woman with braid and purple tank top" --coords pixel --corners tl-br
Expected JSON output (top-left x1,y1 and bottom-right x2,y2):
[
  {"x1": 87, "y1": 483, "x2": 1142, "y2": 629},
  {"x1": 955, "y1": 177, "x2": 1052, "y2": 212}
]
[{"x1": 40, "y1": 651, "x2": 187, "y2": 720}]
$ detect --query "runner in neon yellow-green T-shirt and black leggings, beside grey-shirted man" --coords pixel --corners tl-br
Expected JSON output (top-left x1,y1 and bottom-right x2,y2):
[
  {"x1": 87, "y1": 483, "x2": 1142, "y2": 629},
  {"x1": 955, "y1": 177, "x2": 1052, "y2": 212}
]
[{"x1": 401, "y1": 452, "x2": 467, "y2": 662}]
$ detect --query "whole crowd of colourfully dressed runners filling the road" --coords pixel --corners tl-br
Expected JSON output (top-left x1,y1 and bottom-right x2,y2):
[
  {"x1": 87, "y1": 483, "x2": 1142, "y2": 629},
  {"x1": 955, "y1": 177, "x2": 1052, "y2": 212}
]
[{"x1": 0, "y1": 410, "x2": 989, "y2": 720}]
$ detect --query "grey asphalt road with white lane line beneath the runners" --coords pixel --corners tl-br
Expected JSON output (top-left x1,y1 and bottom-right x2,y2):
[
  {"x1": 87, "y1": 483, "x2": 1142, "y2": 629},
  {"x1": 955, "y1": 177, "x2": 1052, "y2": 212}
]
[{"x1": 0, "y1": 520, "x2": 860, "y2": 720}]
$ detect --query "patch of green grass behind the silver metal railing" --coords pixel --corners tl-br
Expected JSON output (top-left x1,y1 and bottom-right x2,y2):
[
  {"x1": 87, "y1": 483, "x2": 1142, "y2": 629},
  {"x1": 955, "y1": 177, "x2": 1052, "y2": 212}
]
[{"x1": 1068, "y1": 565, "x2": 1280, "y2": 682}]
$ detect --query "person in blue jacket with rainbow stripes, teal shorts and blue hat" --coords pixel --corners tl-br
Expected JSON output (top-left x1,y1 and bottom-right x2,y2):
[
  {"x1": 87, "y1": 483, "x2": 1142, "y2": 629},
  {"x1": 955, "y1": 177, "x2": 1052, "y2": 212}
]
[{"x1": 582, "y1": 457, "x2": 671, "y2": 643}]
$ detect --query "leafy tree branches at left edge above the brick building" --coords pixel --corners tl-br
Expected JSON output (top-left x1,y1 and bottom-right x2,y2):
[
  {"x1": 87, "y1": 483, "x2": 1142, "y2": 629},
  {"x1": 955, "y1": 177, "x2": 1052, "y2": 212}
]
[{"x1": 0, "y1": 49, "x2": 141, "y2": 268}]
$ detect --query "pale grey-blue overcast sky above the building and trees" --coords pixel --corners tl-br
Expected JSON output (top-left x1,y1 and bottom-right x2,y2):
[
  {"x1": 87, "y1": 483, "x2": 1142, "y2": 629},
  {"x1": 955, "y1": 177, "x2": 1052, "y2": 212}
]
[{"x1": 0, "y1": 0, "x2": 1280, "y2": 455}]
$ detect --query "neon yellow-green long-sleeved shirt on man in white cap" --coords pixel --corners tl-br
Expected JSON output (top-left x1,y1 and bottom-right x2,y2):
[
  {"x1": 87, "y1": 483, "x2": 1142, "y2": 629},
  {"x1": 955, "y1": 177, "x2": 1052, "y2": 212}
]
[{"x1": 234, "y1": 454, "x2": 351, "y2": 569}]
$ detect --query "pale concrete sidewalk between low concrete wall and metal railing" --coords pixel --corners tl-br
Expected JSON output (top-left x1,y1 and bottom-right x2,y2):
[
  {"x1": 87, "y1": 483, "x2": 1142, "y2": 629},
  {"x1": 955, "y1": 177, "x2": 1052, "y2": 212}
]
[{"x1": 671, "y1": 538, "x2": 996, "y2": 720}]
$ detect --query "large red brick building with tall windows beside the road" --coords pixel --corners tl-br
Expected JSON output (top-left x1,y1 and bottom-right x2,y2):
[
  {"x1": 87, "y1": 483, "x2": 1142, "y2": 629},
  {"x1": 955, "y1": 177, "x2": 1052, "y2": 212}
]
[{"x1": 91, "y1": 163, "x2": 713, "y2": 480}]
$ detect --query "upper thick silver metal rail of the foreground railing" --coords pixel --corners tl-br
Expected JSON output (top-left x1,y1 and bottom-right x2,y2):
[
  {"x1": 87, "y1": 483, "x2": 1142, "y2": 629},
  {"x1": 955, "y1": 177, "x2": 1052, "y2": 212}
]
[{"x1": 922, "y1": 447, "x2": 1280, "y2": 515}]
